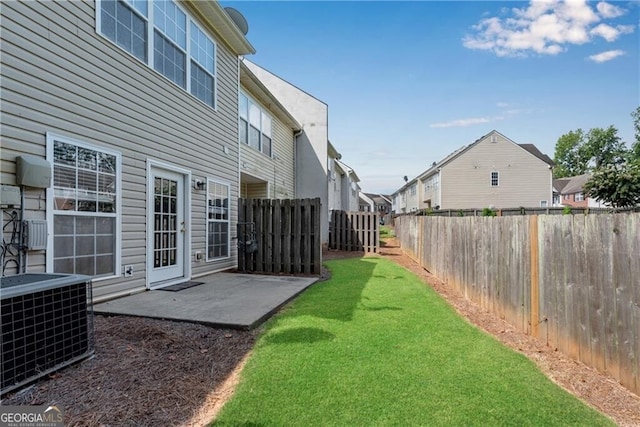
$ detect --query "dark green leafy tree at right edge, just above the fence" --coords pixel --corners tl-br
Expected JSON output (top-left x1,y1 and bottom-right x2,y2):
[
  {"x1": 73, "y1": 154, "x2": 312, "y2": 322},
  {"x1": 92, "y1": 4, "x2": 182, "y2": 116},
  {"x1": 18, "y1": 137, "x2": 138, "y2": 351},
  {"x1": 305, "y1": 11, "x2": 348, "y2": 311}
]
[{"x1": 584, "y1": 161, "x2": 640, "y2": 208}]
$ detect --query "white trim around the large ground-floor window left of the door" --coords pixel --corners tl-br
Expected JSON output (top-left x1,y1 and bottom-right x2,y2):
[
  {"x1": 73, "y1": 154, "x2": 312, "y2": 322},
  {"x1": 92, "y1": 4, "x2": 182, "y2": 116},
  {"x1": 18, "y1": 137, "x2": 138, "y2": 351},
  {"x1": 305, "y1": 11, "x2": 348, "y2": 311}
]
[{"x1": 45, "y1": 132, "x2": 122, "y2": 283}]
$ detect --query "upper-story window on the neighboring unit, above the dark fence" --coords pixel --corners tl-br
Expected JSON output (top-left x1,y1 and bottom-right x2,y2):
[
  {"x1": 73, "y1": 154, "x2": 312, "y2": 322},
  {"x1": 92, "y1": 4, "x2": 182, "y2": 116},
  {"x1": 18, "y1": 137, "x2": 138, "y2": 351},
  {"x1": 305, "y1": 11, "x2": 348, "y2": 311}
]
[{"x1": 238, "y1": 93, "x2": 272, "y2": 157}]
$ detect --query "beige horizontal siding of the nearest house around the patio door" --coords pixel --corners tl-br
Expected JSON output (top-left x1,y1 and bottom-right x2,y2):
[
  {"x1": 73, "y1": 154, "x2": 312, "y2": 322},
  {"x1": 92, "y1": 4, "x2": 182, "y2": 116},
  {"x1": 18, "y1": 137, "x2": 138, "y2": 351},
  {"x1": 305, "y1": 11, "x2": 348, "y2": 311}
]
[{"x1": 0, "y1": 1, "x2": 244, "y2": 300}]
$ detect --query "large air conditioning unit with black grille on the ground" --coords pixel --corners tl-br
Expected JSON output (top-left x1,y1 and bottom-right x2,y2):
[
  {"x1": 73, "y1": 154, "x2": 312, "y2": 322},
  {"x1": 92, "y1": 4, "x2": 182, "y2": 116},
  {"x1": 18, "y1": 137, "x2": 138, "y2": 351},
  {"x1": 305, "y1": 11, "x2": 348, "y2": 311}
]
[{"x1": 0, "y1": 274, "x2": 94, "y2": 394}]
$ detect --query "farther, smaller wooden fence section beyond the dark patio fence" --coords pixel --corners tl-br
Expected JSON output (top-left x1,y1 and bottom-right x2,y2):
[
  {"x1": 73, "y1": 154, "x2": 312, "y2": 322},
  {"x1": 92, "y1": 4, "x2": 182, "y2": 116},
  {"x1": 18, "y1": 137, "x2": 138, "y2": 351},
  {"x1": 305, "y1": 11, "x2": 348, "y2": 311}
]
[{"x1": 329, "y1": 210, "x2": 380, "y2": 253}]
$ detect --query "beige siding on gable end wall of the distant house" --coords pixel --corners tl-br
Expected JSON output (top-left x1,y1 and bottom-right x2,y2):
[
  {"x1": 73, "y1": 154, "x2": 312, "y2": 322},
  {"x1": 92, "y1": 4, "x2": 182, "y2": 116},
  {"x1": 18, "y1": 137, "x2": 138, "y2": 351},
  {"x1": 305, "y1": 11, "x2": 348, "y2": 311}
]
[{"x1": 441, "y1": 134, "x2": 551, "y2": 209}]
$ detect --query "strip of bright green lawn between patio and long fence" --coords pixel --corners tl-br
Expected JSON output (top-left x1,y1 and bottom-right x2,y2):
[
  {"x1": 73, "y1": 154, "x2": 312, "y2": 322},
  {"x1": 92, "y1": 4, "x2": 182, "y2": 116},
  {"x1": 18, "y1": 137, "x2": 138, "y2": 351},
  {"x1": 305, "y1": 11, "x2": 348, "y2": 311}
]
[{"x1": 214, "y1": 258, "x2": 614, "y2": 427}]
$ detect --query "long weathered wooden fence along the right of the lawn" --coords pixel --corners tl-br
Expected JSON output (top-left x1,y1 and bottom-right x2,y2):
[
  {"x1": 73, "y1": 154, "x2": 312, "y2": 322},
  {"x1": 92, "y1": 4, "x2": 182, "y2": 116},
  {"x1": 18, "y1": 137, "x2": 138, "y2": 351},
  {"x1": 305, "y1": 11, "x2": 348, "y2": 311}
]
[{"x1": 395, "y1": 213, "x2": 640, "y2": 394}]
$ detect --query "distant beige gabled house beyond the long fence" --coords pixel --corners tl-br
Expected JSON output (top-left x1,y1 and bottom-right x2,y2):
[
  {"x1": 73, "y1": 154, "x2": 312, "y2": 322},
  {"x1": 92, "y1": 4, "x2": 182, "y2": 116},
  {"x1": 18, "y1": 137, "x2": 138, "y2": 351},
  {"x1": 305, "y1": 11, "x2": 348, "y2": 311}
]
[{"x1": 392, "y1": 130, "x2": 554, "y2": 213}]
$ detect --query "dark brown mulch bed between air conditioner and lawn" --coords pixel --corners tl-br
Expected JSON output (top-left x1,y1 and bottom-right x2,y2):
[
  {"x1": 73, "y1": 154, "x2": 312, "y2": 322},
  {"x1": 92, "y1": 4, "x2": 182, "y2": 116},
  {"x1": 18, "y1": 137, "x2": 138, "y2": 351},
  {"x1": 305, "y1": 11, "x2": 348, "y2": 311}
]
[{"x1": 2, "y1": 316, "x2": 257, "y2": 427}]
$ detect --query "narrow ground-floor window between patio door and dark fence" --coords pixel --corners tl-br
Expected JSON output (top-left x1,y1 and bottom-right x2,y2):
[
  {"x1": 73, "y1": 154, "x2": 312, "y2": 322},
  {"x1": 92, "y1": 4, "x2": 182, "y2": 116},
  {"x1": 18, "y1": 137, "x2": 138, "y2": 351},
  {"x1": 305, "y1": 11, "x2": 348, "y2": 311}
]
[{"x1": 207, "y1": 179, "x2": 231, "y2": 261}]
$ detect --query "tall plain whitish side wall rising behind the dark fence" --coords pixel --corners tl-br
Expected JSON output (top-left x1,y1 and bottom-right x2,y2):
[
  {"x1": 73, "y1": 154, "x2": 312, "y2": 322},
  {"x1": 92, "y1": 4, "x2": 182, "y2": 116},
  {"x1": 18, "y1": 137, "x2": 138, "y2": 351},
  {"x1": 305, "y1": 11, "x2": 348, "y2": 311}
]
[{"x1": 244, "y1": 60, "x2": 329, "y2": 244}]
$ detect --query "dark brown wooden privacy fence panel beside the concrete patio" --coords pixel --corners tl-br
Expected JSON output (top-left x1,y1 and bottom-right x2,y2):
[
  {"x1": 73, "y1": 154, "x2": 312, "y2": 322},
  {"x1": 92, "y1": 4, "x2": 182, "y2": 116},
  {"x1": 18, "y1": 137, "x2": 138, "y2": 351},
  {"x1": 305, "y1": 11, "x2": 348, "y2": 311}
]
[{"x1": 238, "y1": 198, "x2": 322, "y2": 275}]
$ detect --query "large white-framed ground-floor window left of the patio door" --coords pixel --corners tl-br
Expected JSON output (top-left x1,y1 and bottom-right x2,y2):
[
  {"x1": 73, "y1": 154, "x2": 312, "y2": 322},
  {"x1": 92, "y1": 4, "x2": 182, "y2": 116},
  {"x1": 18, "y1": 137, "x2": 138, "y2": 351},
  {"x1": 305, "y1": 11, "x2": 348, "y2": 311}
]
[{"x1": 47, "y1": 134, "x2": 122, "y2": 277}]
